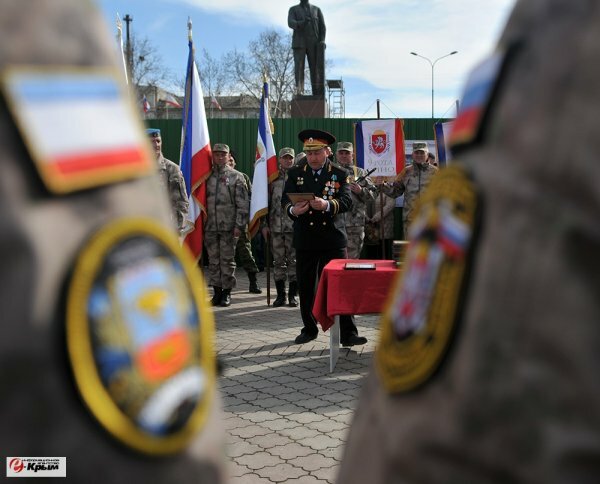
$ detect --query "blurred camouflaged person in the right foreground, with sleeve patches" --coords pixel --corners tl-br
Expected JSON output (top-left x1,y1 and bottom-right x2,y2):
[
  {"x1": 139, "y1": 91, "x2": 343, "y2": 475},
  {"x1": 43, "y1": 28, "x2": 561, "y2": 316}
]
[{"x1": 338, "y1": 0, "x2": 600, "y2": 484}]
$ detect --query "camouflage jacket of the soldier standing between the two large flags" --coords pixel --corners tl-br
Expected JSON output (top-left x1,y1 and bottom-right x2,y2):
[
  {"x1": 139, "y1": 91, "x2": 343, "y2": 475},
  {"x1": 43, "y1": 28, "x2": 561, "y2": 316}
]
[{"x1": 204, "y1": 165, "x2": 250, "y2": 232}]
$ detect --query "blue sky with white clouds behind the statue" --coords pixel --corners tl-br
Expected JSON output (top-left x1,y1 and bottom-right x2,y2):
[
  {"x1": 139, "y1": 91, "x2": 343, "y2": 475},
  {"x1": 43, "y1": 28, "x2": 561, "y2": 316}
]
[{"x1": 96, "y1": 0, "x2": 516, "y2": 118}]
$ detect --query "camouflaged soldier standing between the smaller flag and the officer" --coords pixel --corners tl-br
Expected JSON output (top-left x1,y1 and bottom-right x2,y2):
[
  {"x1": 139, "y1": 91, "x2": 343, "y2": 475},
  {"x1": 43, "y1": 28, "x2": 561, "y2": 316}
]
[{"x1": 262, "y1": 148, "x2": 298, "y2": 308}]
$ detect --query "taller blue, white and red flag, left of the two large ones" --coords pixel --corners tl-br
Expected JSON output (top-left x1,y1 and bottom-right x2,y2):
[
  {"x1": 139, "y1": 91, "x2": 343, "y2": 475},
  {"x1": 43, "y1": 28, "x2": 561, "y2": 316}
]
[{"x1": 179, "y1": 21, "x2": 212, "y2": 260}]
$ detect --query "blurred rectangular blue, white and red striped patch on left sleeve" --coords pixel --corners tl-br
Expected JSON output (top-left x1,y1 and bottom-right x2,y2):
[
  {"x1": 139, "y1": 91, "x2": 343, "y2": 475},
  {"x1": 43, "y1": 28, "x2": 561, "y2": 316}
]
[{"x1": 0, "y1": 67, "x2": 154, "y2": 194}]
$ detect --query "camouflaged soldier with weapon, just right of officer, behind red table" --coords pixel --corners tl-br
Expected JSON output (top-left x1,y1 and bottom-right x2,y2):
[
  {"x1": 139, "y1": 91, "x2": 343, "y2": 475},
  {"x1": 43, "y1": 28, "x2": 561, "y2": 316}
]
[{"x1": 336, "y1": 141, "x2": 376, "y2": 259}]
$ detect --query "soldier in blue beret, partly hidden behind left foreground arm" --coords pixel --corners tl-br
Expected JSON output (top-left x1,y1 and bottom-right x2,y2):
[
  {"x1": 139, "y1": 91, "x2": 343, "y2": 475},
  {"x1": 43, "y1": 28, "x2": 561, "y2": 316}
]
[{"x1": 146, "y1": 128, "x2": 189, "y2": 234}]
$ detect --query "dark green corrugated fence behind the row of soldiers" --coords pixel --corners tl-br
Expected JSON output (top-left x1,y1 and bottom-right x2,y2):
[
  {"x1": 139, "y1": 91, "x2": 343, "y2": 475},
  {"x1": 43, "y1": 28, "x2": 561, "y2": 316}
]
[{"x1": 146, "y1": 118, "x2": 446, "y2": 176}]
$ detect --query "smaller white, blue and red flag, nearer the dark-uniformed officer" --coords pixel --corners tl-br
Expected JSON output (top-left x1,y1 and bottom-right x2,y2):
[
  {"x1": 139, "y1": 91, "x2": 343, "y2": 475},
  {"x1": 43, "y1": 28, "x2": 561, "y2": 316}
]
[{"x1": 248, "y1": 82, "x2": 279, "y2": 237}]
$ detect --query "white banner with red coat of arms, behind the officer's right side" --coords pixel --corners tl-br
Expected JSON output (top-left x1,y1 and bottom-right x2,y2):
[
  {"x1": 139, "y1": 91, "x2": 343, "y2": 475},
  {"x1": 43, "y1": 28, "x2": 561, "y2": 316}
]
[{"x1": 354, "y1": 119, "x2": 405, "y2": 178}]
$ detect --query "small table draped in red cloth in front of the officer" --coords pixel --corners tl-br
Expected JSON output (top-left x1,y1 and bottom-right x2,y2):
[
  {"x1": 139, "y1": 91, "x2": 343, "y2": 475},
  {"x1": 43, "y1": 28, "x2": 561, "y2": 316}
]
[{"x1": 313, "y1": 259, "x2": 398, "y2": 371}]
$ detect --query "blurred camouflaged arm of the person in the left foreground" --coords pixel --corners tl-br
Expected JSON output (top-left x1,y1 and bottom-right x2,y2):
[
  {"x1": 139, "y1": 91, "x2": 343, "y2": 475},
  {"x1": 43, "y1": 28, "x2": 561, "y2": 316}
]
[{"x1": 0, "y1": 0, "x2": 226, "y2": 484}]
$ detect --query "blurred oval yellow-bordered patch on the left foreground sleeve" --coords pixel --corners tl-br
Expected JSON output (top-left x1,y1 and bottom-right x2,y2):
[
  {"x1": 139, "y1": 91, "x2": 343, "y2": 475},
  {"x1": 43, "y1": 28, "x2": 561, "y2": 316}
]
[{"x1": 66, "y1": 219, "x2": 215, "y2": 454}]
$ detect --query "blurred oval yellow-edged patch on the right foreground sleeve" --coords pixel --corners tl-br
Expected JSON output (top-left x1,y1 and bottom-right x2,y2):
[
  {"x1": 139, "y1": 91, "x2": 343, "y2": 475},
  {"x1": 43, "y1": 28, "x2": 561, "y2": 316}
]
[{"x1": 375, "y1": 164, "x2": 478, "y2": 393}]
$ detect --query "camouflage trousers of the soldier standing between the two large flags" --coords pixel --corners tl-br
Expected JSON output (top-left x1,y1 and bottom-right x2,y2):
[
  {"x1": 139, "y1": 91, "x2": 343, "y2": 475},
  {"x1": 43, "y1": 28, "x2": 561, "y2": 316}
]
[{"x1": 204, "y1": 231, "x2": 237, "y2": 289}]
